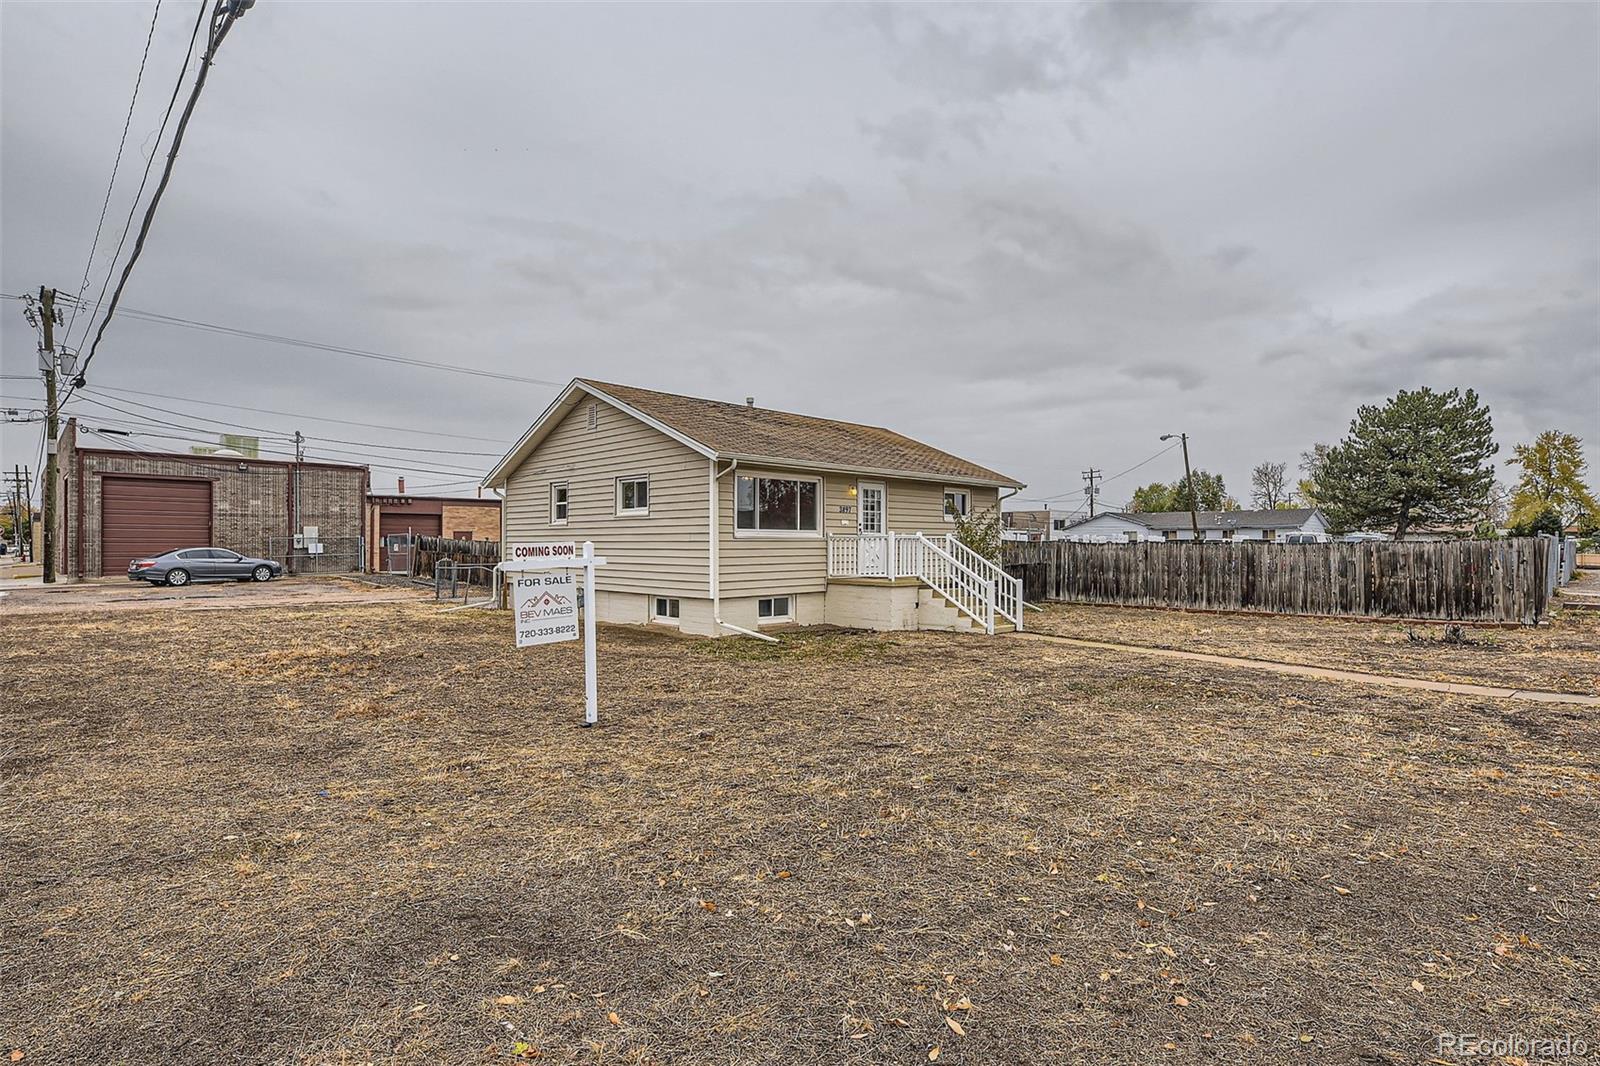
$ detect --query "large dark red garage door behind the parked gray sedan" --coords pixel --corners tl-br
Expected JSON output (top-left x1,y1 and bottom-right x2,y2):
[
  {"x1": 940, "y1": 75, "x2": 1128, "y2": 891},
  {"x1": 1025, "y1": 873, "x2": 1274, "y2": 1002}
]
[{"x1": 101, "y1": 477, "x2": 211, "y2": 575}]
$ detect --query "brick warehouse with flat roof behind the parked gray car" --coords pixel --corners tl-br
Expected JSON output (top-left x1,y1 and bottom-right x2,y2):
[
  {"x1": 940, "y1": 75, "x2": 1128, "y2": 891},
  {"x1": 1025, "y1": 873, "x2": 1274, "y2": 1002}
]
[{"x1": 54, "y1": 419, "x2": 371, "y2": 579}]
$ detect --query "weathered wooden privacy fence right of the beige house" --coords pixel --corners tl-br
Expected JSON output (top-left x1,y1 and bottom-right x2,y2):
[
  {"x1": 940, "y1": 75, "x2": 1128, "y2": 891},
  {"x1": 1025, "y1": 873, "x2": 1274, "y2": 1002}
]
[{"x1": 1005, "y1": 538, "x2": 1550, "y2": 626}]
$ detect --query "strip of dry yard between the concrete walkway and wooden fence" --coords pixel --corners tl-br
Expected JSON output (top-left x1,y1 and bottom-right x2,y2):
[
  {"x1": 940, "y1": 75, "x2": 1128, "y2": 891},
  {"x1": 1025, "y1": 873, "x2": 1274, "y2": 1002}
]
[{"x1": 1024, "y1": 603, "x2": 1600, "y2": 695}]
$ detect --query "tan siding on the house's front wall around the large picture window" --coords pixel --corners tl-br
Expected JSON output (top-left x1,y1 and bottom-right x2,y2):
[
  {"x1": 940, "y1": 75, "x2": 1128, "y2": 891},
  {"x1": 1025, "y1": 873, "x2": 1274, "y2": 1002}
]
[{"x1": 717, "y1": 467, "x2": 998, "y2": 597}]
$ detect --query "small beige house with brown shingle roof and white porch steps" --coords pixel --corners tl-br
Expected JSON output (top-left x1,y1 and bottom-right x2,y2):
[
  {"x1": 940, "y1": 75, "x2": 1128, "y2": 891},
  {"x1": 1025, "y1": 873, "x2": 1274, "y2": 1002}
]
[{"x1": 483, "y1": 378, "x2": 1022, "y2": 637}]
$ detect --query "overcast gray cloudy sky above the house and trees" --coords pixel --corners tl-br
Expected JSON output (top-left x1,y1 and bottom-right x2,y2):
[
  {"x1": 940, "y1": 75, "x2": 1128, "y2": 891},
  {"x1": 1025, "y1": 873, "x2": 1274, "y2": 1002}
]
[{"x1": 0, "y1": 0, "x2": 1600, "y2": 509}]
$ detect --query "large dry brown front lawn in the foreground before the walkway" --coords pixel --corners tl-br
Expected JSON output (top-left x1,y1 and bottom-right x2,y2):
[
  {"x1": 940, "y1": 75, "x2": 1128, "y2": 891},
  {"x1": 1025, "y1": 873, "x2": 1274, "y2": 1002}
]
[{"x1": 0, "y1": 605, "x2": 1600, "y2": 1064}]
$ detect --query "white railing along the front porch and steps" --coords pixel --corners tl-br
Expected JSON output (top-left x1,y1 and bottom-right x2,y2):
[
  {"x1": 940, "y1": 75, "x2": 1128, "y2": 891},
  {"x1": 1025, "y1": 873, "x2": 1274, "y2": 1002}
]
[{"x1": 827, "y1": 533, "x2": 1022, "y2": 634}]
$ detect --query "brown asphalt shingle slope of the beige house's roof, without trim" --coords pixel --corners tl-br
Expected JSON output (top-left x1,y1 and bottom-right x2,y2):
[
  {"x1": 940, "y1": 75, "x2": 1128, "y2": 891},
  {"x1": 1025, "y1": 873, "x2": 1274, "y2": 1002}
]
[{"x1": 582, "y1": 379, "x2": 1021, "y2": 487}]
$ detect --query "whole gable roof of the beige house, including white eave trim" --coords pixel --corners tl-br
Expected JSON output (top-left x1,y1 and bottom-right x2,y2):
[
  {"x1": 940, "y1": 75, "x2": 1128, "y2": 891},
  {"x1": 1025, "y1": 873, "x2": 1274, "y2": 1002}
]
[{"x1": 483, "y1": 378, "x2": 1022, "y2": 488}]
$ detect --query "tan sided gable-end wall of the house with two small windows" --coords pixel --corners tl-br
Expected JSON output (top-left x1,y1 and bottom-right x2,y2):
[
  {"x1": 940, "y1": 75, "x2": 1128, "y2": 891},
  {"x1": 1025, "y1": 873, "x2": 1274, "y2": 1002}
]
[{"x1": 502, "y1": 399, "x2": 710, "y2": 598}]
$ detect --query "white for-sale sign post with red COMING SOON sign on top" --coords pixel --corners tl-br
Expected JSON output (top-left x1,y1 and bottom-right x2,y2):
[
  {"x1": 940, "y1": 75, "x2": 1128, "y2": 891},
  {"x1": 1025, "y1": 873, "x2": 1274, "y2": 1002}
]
[{"x1": 499, "y1": 541, "x2": 605, "y2": 727}]
